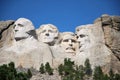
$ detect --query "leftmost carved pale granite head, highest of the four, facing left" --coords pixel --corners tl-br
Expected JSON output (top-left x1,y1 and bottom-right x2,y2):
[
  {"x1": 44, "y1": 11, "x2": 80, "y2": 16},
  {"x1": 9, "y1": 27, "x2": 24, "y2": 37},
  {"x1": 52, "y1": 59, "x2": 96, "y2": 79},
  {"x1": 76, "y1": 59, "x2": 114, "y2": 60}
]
[{"x1": 14, "y1": 18, "x2": 34, "y2": 40}]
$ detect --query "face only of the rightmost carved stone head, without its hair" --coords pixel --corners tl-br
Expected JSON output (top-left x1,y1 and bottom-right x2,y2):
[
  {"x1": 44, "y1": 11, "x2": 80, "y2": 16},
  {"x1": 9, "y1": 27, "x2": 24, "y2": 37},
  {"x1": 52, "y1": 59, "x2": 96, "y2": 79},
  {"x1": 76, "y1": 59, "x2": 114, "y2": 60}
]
[{"x1": 77, "y1": 29, "x2": 90, "y2": 52}]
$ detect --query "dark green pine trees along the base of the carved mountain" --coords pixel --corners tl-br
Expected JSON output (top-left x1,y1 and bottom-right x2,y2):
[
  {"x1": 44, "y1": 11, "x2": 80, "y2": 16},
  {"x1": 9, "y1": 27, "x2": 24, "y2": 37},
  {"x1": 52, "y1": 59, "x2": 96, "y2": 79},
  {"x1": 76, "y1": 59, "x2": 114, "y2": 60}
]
[{"x1": 0, "y1": 58, "x2": 120, "y2": 80}]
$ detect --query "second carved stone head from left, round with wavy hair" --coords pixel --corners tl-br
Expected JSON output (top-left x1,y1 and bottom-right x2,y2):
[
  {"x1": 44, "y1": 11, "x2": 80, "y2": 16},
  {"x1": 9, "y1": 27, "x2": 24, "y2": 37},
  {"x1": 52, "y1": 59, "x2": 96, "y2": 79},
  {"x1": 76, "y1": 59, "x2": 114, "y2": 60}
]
[{"x1": 37, "y1": 24, "x2": 59, "y2": 45}]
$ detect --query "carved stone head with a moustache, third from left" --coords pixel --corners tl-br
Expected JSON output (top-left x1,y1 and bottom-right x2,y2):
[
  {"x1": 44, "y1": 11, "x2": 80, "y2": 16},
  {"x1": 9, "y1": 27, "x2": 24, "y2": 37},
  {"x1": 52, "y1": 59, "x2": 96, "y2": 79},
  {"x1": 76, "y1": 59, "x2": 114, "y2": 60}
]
[{"x1": 60, "y1": 33, "x2": 77, "y2": 54}]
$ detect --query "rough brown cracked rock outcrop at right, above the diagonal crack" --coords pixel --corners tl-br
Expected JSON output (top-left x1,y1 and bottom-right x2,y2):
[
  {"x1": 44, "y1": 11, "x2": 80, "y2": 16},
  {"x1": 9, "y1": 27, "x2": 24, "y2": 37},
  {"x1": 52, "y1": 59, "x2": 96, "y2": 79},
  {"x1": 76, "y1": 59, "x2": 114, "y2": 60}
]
[{"x1": 95, "y1": 15, "x2": 120, "y2": 60}]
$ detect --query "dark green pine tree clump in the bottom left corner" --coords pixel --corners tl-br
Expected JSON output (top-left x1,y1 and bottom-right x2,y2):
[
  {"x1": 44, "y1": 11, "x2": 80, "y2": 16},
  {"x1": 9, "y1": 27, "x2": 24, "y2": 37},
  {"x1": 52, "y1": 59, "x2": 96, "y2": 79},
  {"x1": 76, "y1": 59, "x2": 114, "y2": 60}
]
[{"x1": 0, "y1": 62, "x2": 30, "y2": 80}]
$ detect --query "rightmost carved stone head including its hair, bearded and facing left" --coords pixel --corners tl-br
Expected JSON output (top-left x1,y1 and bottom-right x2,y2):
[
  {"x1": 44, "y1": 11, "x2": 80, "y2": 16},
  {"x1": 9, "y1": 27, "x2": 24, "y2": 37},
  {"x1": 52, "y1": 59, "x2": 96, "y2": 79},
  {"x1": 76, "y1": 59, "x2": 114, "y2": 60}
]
[{"x1": 76, "y1": 24, "x2": 93, "y2": 52}]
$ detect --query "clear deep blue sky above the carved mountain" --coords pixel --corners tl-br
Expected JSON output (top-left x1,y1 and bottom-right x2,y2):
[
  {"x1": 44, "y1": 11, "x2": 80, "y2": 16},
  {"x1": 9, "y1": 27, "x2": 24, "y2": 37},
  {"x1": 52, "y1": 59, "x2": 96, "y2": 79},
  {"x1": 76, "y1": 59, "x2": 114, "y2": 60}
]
[{"x1": 0, "y1": 0, "x2": 120, "y2": 32}]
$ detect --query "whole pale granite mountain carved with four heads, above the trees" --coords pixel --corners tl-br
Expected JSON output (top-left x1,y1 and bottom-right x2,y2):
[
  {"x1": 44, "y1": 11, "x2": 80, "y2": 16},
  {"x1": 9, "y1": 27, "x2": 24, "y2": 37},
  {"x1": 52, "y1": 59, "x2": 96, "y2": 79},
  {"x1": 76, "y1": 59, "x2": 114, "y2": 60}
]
[{"x1": 0, "y1": 15, "x2": 120, "y2": 72}]
